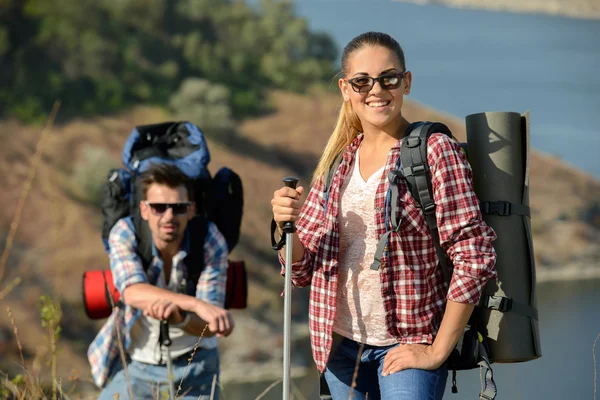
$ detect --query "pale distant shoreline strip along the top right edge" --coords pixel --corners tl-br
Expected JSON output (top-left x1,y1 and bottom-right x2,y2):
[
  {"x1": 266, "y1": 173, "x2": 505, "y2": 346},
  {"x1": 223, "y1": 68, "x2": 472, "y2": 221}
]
[{"x1": 393, "y1": 0, "x2": 600, "y2": 20}]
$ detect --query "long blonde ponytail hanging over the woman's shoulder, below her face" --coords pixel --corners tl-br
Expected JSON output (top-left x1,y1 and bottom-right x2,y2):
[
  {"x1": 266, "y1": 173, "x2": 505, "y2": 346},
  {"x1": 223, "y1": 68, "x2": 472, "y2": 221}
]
[{"x1": 312, "y1": 101, "x2": 362, "y2": 184}]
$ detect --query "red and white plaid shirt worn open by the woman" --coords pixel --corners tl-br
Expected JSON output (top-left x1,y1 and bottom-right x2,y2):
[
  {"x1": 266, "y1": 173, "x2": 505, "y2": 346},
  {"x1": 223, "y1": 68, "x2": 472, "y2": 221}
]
[{"x1": 279, "y1": 133, "x2": 496, "y2": 371}]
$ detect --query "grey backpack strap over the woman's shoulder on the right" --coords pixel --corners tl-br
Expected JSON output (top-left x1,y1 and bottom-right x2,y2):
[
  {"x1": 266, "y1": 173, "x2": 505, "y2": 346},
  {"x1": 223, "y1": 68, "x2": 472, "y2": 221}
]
[{"x1": 400, "y1": 122, "x2": 452, "y2": 282}]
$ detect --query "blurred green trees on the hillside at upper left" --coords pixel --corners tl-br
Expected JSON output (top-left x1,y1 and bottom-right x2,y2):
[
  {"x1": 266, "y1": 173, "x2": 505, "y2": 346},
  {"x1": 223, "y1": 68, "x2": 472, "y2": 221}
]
[{"x1": 0, "y1": 0, "x2": 337, "y2": 120}]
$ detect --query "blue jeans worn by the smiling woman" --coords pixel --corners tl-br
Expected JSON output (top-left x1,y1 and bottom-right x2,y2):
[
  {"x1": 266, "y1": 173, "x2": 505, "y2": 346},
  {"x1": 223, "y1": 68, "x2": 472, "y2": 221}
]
[{"x1": 325, "y1": 333, "x2": 448, "y2": 400}]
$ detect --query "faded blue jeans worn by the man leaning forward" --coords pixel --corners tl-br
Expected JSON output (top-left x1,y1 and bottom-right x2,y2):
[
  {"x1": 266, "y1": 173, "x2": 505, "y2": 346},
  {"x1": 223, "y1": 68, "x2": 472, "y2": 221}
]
[{"x1": 99, "y1": 348, "x2": 219, "y2": 400}]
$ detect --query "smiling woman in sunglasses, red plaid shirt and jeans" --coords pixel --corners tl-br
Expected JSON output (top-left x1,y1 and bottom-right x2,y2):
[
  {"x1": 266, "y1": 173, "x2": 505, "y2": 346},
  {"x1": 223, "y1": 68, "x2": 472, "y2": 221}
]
[{"x1": 271, "y1": 32, "x2": 496, "y2": 400}]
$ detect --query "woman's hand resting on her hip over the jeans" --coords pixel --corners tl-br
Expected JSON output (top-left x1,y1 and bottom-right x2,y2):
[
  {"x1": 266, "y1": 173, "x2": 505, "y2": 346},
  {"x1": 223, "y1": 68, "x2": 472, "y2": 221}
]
[{"x1": 381, "y1": 344, "x2": 445, "y2": 376}]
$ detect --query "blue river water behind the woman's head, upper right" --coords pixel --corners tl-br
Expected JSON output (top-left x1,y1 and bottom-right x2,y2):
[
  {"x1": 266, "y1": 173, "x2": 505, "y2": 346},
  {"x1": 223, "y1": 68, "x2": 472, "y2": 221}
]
[{"x1": 296, "y1": 0, "x2": 600, "y2": 178}]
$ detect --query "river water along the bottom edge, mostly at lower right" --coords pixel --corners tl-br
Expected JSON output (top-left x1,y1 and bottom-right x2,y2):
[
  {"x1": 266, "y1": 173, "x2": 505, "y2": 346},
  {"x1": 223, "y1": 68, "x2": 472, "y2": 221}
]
[{"x1": 223, "y1": 280, "x2": 600, "y2": 400}]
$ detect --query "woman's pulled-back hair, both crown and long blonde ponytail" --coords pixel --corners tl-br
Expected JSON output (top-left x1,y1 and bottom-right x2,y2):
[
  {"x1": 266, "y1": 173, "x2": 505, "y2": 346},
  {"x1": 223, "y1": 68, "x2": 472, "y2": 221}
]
[{"x1": 312, "y1": 32, "x2": 406, "y2": 184}]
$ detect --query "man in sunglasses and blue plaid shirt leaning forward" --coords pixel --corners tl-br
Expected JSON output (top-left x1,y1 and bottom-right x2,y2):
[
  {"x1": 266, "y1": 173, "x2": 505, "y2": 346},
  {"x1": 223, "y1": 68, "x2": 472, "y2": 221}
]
[{"x1": 88, "y1": 164, "x2": 234, "y2": 399}]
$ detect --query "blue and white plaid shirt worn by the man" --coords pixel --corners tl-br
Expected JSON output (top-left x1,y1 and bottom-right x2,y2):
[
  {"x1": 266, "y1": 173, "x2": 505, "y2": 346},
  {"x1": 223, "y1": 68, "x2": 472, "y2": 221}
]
[{"x1": 88, "y1": 217, "x2": 228, "y2": 388}]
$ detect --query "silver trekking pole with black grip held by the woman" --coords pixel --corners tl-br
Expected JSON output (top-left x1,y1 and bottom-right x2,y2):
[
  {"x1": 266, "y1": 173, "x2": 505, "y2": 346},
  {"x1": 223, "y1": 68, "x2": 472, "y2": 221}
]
[{"x1": 282, "y1": 177, "x2": 298, "y2": 400}]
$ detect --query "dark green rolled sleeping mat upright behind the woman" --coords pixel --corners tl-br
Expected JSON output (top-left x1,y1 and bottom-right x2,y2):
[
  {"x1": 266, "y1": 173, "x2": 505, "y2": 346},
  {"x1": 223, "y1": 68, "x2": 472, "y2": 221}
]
[{"x1": 466, "y1": 112, "x2": 542, "y2": 363}]
